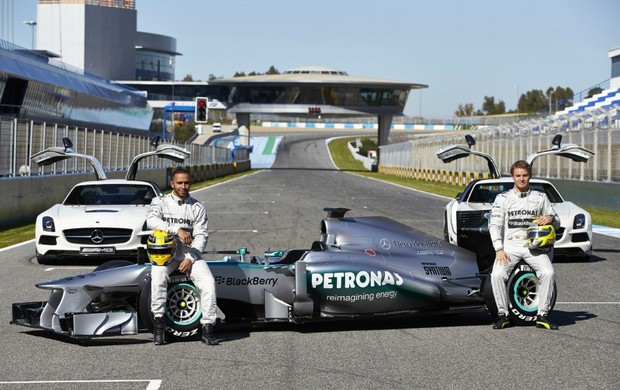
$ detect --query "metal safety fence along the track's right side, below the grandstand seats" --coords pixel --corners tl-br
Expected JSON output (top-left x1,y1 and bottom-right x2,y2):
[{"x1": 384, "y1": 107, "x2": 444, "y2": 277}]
[{"x1": 378, "y1": 116, "x2": 620, "y2": 185}]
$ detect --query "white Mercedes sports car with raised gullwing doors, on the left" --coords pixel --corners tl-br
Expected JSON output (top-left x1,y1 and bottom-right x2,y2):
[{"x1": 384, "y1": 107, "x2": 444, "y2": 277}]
[{"x1": 31, "y1": 139, "x2": 189, "y2": 264}]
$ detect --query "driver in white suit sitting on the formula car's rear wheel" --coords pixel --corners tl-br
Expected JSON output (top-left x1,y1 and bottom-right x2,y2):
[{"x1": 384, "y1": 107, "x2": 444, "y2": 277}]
[{"x1": 489, "y1": 160, "x2": 560, "y2": 329}]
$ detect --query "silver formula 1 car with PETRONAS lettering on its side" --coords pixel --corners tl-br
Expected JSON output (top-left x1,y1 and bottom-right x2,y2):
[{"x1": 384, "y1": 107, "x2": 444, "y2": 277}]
[{"x1": 12, "y1": 208, "x2": 552, "y2": 339}]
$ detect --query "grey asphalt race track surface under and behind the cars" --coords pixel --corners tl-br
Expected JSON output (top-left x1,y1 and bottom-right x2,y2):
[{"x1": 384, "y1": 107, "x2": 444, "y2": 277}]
[{"x1": 0, "y1": 133, "x2": 620, "y2": 390}]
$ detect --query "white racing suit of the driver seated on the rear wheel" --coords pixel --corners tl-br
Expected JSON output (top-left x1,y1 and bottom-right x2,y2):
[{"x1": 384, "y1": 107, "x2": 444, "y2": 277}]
[{"x1": 489, "y1": 189, "x2": 560, "y2": 316}]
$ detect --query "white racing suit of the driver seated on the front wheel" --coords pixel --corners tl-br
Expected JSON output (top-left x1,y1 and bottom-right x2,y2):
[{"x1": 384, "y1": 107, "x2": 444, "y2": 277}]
[{"x1": 146, "y1": 194, "x2": 217, "y2": 325}]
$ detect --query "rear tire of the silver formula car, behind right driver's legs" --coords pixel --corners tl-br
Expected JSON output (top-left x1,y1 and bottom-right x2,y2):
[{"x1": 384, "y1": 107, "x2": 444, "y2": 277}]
[{"x1": 482, "y1": 261, "x2": 557, "y2": 325}]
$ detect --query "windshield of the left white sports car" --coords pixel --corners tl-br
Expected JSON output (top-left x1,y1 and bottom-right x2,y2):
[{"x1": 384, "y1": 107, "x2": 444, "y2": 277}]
[{"x1": 64, "y1": 184, "x2": 155, "y2": 206}]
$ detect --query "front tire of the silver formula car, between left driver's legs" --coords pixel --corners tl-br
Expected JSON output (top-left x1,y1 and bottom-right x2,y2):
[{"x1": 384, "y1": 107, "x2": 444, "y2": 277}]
[{"x1": 138, "y1": 272, "x2": 202, "y2": 340}]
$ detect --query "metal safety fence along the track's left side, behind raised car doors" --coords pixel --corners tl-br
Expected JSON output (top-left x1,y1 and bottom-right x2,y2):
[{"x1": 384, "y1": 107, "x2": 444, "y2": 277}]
[{"x1": 0, "y1": 117, "x2": 249, "y2": 178}]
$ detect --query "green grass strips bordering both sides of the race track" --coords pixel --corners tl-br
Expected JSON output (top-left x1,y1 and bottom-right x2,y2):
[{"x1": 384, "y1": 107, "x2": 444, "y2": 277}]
[{"x1": 0, "y1": 137, "x2": 620, "y2": 248}]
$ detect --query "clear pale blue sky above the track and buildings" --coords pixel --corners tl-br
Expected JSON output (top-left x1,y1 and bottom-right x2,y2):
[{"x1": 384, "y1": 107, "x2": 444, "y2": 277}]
[{"x1": 0, "y1": 0, "x2": 620, "y2": 119}]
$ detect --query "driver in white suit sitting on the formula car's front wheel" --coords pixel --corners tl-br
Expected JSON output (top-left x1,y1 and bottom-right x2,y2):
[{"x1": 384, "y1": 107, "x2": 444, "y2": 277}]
[{"x1": 146, "y1": 168, "x2": 218, "y2": 345}]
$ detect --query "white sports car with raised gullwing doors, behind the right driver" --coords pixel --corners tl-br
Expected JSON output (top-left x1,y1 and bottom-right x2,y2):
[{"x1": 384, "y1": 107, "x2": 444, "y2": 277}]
[{"x1": 437, "y1": 135, "x2": 594, "y2": 267}]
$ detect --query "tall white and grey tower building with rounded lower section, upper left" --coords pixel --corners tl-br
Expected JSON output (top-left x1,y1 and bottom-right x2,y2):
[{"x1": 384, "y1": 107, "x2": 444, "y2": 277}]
[{"x1": 36, "y1": 0, "x2": 180, "y2": 81}]
